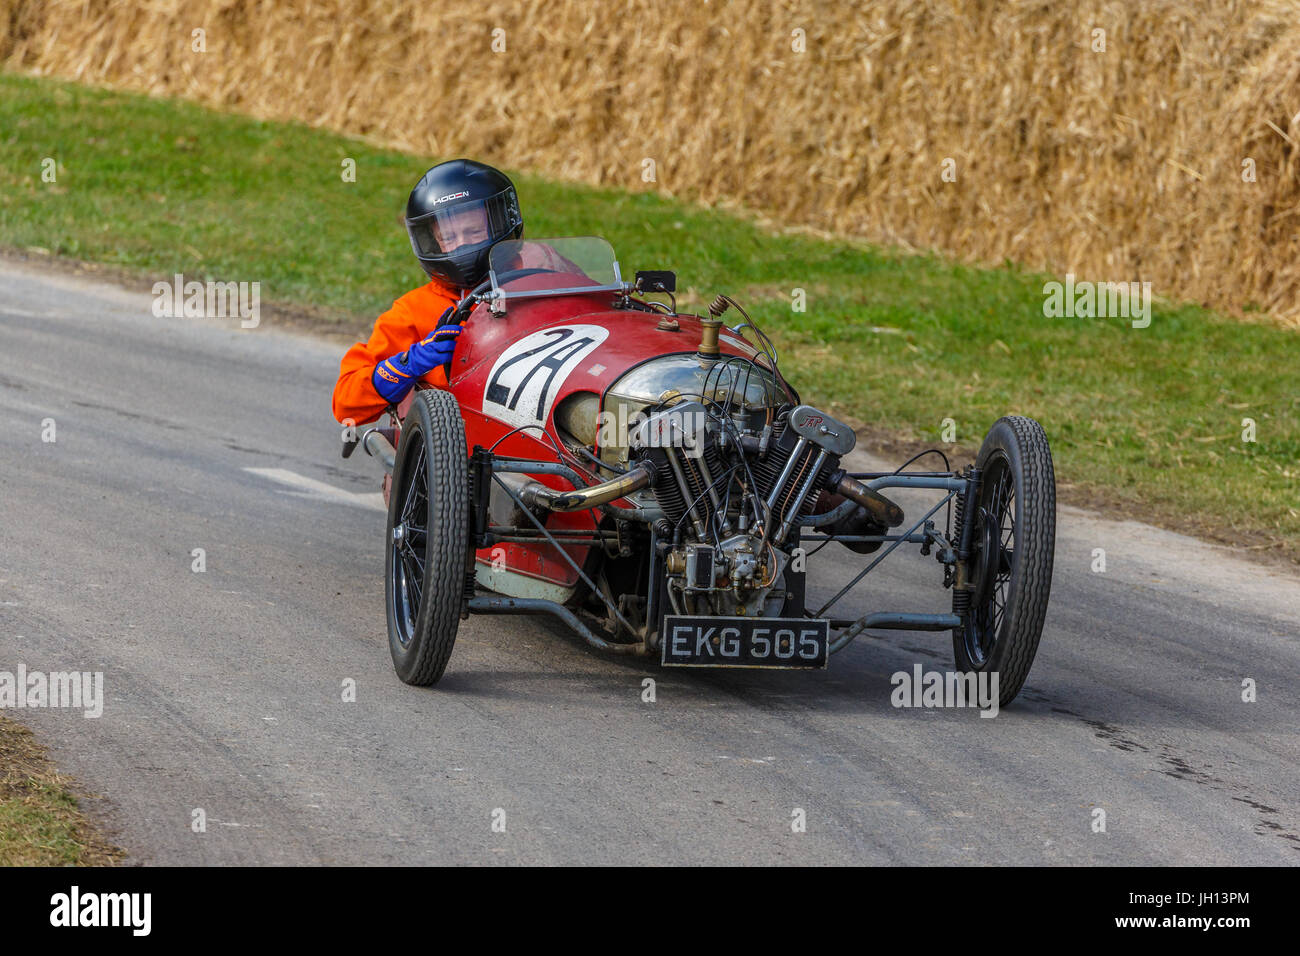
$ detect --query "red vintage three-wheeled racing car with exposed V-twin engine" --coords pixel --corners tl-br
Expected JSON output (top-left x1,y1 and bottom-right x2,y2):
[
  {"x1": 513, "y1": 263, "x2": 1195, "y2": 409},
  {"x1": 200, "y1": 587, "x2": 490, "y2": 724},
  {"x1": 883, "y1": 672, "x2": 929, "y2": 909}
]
[{"x1": 345, "y1": 237, "x2": 1056, "y2": 704}]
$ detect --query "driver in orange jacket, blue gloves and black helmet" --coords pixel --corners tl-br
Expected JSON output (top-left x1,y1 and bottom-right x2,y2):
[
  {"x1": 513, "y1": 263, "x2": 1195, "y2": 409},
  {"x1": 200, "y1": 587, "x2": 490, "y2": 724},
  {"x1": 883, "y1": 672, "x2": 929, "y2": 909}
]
[{"x1": 334, "y1": 159, "x2": 524, "y2": 424}]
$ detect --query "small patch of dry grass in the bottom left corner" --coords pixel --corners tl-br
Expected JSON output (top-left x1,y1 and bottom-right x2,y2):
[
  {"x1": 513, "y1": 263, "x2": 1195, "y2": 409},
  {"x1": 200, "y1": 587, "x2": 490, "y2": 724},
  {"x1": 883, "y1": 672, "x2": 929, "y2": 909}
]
[{"x1": 0, "y1": 717, "x2": 122, "y2": 866}]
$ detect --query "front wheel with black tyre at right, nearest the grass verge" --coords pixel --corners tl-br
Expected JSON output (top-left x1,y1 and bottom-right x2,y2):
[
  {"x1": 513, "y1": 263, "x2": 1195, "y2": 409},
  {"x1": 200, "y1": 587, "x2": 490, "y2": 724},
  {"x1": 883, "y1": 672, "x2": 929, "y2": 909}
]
[{"x1": 953, "y1": 415, "x2": 1056, "y2": 706}]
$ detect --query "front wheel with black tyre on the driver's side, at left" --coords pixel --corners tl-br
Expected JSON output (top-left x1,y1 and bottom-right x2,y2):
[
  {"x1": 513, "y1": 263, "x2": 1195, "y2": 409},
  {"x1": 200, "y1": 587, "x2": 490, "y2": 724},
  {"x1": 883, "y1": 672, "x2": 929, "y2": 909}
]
[{"x1": 384, "y1": 389, "x2": 469, "y2": 687}]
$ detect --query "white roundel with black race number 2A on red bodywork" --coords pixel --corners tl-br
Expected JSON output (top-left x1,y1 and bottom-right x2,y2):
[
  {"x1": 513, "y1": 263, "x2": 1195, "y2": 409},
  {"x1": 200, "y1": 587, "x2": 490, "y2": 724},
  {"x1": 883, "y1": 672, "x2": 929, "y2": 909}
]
[{"x1": 484, "y1": 325, "x2": 610, "y2": 428}]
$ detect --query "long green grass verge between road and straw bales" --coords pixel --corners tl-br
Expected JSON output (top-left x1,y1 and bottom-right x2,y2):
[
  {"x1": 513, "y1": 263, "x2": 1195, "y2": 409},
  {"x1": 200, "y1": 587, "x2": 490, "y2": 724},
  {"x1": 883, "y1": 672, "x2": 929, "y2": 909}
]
[{"x1": 0, "y1": 74, "x2": 1300, "y2": 563}]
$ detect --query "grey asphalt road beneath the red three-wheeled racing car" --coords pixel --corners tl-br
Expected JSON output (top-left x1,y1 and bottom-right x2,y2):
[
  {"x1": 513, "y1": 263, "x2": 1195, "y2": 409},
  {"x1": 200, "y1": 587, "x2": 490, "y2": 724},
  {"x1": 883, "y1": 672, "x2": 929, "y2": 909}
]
[{"x1": 0, "y1": 264, "x2": 1300, "y2": 864}]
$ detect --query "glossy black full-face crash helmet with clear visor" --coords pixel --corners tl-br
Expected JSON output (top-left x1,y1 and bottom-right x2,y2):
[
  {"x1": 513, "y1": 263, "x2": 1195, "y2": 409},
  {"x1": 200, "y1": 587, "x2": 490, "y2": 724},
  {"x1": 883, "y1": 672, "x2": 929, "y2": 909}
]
[{"x1": 406, "y1": 160, "x2": 524, "y2": 289}]
